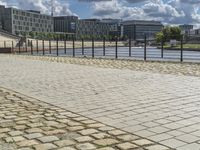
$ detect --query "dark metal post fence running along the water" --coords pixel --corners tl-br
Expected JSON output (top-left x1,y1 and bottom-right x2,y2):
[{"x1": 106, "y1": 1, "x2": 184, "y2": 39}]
[{"x1": 0, "y1": 36, "x2": 200, "y2": 62}]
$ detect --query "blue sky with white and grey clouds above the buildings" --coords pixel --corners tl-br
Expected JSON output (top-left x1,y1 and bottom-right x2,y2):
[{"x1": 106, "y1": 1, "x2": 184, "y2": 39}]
[{"x1": 0, "y1": 0, "x2": 200, "y2": 26}]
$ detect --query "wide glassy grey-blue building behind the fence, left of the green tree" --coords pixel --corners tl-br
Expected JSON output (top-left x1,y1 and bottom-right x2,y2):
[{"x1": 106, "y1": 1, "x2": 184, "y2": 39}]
[{"x1": 121, "y1": 20, "x2": 163, "y2": 40}]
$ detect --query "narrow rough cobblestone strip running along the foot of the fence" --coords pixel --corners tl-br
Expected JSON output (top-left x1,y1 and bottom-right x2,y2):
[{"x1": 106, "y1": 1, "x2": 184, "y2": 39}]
[{"x1": 14, "y1": 55, "x2": 200, "y2": 77}]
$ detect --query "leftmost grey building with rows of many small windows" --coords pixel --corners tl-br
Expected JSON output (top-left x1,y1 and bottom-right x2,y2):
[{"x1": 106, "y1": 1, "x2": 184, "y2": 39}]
[{"x1": 0, "y1": 6, "x2": 53, "y2": 34}]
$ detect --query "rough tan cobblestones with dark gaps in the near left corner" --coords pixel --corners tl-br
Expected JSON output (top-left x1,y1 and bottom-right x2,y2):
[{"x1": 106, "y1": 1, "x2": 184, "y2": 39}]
[{"x1": 0, "y1": 88, "x2": 173, "y2": 150}]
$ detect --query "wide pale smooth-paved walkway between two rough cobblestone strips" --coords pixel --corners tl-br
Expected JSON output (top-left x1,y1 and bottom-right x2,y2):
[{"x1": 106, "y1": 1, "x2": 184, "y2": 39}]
[{"x1": 0, "y1": 55, "x2": 200, "y2": 150}]
